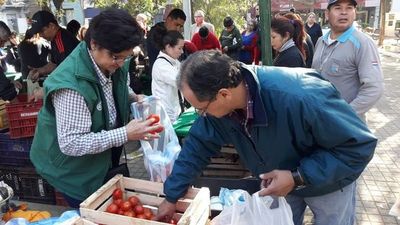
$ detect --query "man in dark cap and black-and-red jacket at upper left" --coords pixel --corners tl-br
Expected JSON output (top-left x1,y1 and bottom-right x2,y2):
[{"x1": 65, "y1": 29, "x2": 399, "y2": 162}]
[{"x1": 29, "y1": 10, "x2": 79, "y2": 82}]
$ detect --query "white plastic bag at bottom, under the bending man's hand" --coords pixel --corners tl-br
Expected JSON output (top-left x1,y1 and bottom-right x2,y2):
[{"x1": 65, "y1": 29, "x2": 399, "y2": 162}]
[{"x1": 211, "y1": 192, "x2": 293, "y2": 225}]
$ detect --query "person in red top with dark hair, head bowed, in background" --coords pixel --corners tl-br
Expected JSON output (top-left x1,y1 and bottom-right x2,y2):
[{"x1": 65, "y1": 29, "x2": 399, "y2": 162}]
[{"x1": 192, "y1": 26, "x2": 221, "y2": 50}]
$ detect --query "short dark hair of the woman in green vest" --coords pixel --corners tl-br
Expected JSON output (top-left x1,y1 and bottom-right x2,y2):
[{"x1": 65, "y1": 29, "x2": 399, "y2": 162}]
[{"x1": 85, "y1": 8, "x2": 143, "y2": 53}]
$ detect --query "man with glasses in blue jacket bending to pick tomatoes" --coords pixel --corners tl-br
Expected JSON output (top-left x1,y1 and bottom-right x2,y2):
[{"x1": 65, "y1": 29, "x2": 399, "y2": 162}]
[{"x1": 157, "y1": 50, "x2": 377, "y2": 225}]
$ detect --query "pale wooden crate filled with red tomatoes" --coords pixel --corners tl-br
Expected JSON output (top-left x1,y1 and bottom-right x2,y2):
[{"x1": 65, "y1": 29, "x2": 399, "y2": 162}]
[{"x1": 80, "y1": 174, "x2": 210, "y2": 225}]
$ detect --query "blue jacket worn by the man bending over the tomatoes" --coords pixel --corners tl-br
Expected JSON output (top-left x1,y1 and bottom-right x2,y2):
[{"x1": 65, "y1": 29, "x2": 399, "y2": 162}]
[{"x1": 164, "y1": 66, "x2": 377, "y2": 202}]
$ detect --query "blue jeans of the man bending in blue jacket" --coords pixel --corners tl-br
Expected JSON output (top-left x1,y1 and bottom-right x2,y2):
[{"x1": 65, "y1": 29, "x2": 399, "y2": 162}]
[{"x1": 286, "y1": 181, "x2": 356, "y2": 225}]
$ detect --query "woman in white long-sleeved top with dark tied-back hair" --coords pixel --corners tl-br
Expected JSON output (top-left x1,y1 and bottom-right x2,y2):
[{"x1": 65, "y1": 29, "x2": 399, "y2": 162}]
[{"x1": 151, "y1": 31, "x2": 185, "y2": 122}]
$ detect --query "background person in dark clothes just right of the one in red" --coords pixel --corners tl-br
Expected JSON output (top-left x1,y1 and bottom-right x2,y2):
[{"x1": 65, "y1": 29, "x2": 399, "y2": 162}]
[{"x1": 219, "y1": 16, "x2": 242, "y2": 60}]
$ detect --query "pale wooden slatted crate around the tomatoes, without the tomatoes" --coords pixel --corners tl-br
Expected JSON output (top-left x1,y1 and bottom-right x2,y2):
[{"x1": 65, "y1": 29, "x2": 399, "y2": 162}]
[{"x1": 80, "y1": 174, "x2": 210, "y2": 225}]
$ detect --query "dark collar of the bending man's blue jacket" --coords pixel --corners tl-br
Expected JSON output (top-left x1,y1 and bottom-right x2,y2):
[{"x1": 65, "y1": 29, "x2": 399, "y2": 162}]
[{"x1": 241, "y1": 64, "x2": 268, "y2": 126}]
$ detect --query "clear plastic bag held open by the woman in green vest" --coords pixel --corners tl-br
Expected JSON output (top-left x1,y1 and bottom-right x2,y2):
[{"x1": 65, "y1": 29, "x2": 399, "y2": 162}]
[{"x1": 131, "y1": 96, "x2": 181, "y2": 182}]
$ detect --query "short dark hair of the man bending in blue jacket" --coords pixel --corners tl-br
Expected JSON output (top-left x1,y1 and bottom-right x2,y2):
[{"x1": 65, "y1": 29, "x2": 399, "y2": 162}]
[{"x1": 177, "y1": 50, "x2": 243, "y2": 102}]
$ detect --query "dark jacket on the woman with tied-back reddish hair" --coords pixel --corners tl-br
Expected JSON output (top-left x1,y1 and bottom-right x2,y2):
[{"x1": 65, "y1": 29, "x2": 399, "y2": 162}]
[{"x1": 272, "y1": 46, "x2": 306, "y2": 67}]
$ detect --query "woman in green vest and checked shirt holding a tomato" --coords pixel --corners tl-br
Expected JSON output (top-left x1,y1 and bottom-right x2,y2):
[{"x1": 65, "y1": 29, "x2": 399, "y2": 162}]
[{"x1": 30, "y1": 8, "x2": 162, "y2": 208}]
